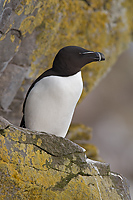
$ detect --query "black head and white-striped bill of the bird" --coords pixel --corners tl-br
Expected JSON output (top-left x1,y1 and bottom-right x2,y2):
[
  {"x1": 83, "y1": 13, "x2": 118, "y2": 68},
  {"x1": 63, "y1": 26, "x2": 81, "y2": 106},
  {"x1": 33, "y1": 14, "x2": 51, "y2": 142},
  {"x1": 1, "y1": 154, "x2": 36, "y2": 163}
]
[{"x1": 53, "y1": 46, "x2": 105, "y2": 76}]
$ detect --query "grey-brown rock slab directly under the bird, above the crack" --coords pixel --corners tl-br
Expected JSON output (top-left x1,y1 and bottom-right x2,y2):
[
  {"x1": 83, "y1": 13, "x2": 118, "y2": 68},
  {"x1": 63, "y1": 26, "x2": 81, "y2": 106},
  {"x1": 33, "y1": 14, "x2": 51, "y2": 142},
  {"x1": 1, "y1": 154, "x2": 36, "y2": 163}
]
[{"x1": 0, "y1": 118, "x2": 85, "y2": 156}]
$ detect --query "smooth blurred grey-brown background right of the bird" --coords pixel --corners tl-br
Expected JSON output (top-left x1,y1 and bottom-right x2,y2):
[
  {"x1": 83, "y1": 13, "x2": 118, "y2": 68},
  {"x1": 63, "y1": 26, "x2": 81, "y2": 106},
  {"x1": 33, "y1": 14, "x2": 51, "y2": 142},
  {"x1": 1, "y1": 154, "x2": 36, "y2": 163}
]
[{"x1": 73, "y1": 43, "x2": 133, "y2": 197}]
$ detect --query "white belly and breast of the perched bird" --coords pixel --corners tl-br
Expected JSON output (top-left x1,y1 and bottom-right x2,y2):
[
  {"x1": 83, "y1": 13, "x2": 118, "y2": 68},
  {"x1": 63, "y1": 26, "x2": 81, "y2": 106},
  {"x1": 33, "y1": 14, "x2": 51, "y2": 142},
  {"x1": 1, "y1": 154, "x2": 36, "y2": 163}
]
[{"x1": 25, "y1": 72, "x2": 83, "y2": 137}]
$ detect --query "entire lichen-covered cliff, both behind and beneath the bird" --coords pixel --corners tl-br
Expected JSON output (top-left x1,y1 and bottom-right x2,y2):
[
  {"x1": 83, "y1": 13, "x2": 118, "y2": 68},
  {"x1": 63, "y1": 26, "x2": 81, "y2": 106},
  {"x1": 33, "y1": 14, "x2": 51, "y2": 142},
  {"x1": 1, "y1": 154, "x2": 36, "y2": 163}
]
[{"x1": 0, "y1": 0, "x2": 133, "y2": 200}]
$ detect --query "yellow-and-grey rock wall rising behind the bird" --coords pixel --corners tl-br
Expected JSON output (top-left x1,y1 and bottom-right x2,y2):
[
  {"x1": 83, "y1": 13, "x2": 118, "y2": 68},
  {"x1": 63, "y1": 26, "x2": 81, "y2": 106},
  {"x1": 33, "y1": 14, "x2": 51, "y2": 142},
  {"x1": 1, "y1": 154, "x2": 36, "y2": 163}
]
[{"x1": 0, "y1": 0, "x2": 133, "y2": 124}]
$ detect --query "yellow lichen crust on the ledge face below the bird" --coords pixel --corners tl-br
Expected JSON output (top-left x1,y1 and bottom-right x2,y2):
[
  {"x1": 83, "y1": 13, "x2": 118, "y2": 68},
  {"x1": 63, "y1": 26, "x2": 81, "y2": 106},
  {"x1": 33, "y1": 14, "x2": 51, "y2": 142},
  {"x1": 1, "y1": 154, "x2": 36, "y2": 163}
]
[{"x1": 0, "y1": 126, "x2": 127, "y2": 200}]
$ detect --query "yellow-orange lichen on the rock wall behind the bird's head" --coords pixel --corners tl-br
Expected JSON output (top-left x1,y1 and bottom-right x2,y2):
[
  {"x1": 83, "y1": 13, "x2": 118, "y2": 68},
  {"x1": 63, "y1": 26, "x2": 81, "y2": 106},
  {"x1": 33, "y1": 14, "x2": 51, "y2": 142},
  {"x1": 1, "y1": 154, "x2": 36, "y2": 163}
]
[{"x1": 1, "y1": 0, "x2": 133, "y2": 99}]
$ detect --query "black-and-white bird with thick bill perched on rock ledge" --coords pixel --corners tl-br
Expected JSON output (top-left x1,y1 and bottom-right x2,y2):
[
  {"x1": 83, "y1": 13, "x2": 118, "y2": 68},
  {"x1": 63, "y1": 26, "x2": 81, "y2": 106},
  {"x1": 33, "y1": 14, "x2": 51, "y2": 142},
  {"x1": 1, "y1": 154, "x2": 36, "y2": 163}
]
[{"x1": 20, "y1": 46, "x2": 105, "y2": 138}]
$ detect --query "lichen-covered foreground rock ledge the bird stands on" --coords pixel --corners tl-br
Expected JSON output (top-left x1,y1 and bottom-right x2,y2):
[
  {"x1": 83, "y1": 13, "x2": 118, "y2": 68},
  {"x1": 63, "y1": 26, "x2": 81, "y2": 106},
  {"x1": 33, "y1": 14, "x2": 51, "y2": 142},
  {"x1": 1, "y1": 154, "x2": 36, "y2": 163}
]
[{"x1": 0, "y1": 117, "x2": 130, "y2": 200}]
